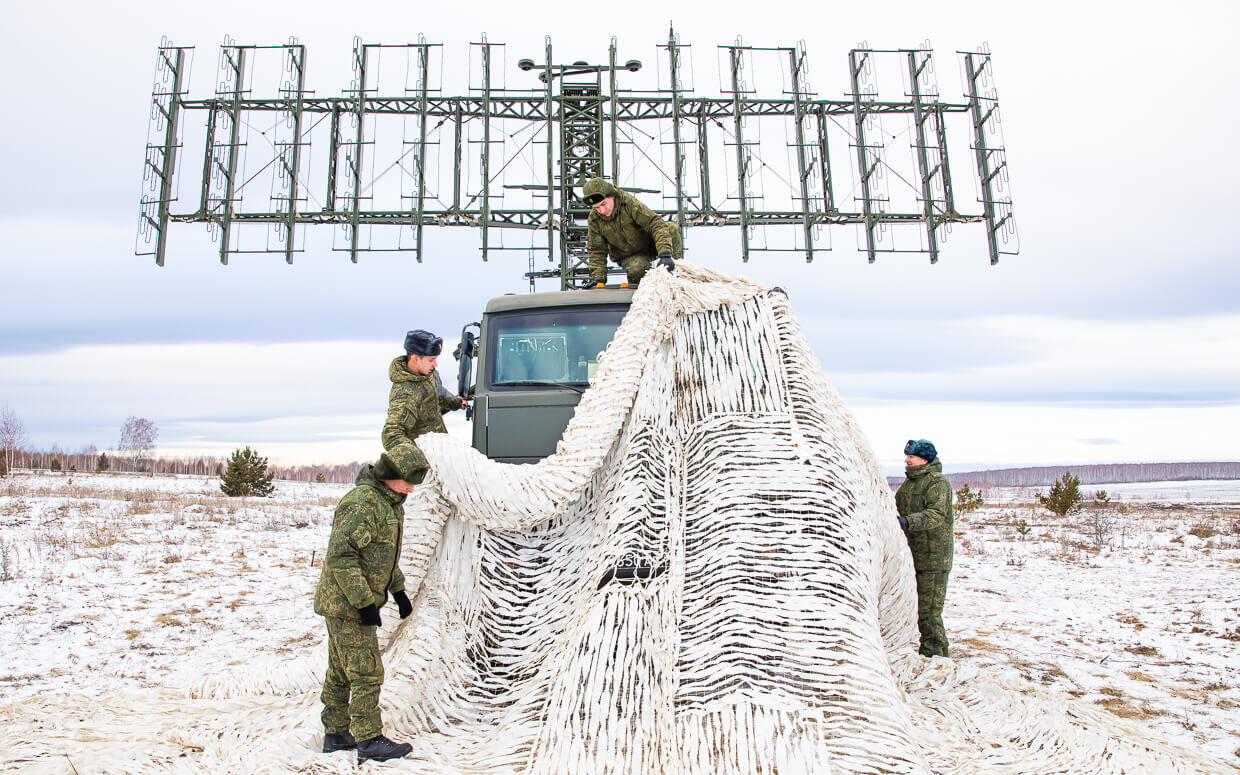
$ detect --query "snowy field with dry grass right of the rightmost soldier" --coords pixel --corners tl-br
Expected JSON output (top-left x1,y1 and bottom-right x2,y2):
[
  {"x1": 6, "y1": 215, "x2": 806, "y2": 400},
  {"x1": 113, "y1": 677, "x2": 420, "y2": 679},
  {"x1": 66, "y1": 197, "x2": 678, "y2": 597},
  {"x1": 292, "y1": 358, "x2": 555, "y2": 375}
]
[{"x1": 944, "y1": 481, "x2": 1240, "y2": 764}]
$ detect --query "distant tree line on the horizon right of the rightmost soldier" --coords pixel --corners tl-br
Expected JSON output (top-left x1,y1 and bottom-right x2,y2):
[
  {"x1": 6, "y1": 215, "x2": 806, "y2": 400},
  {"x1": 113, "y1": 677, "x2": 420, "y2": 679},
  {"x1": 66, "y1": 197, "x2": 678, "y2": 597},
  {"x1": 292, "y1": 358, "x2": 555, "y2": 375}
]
[{"x1": 942, "y1": 463, "x2": 1240, "y2": 487}]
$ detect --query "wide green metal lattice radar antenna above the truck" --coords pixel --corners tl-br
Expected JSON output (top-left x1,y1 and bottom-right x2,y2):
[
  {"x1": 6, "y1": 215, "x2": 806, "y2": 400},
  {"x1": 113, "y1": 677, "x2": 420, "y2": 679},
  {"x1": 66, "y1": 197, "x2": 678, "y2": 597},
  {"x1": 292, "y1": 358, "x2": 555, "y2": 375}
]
[{"x1": 136, "y1": 31, "x2": 1018, "y2": 289}]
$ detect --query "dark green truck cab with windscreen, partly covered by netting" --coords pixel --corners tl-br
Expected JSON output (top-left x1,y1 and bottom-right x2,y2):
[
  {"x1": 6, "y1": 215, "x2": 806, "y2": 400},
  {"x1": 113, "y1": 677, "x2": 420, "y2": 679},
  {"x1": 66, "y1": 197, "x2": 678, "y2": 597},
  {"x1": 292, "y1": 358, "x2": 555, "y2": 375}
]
[{"x1": 459, "y1": 288, "x2": 634, "y2": 463}]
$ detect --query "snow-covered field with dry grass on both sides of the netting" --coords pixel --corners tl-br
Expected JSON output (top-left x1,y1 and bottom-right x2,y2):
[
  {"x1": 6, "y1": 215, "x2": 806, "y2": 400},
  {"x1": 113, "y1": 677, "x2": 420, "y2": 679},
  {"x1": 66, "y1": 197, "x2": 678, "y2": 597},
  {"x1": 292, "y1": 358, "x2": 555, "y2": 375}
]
[{"x1": 0, "y1": 472, "x2": 1240, "y2": 764}]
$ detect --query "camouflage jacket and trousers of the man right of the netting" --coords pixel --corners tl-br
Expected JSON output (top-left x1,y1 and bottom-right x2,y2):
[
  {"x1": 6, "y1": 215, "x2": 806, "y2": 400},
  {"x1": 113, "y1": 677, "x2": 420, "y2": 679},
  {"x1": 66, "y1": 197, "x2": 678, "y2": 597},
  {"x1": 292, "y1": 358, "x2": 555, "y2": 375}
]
[{"x1": 895, "y1": 460, "x2": 952, "y2": 657}]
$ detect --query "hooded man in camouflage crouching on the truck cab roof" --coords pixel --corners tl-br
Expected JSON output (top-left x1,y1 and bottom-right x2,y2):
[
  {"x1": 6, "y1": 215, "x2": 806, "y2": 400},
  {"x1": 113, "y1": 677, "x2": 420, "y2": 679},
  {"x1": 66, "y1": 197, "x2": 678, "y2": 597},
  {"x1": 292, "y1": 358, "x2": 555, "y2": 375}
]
[{"x1": 582, "y1": 177, "x2": 684, "y2": 288}]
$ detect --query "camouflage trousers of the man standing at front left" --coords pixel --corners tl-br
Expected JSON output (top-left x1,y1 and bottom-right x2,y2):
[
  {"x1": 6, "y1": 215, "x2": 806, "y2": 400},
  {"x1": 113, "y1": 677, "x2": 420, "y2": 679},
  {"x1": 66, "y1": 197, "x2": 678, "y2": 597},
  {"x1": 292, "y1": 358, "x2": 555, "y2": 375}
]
[{"x1": 319, "y1": 616, "x2": 383, "y2": 740}]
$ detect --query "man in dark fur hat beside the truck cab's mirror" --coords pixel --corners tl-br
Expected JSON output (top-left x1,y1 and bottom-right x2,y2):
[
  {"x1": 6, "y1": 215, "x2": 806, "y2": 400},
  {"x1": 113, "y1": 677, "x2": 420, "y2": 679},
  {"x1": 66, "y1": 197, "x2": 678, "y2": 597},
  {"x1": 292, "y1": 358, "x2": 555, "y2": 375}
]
[{"x1": 382, "y1": 329, "x2": 466, "y2": 478}]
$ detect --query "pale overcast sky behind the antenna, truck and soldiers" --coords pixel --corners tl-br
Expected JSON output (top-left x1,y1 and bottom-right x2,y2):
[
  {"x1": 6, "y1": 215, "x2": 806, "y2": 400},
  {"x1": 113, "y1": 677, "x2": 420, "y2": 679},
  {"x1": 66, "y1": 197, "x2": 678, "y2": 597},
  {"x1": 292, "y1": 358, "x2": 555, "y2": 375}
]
[{"x1": 0, "y1": 0, "x2": 1240, "y2": 471}]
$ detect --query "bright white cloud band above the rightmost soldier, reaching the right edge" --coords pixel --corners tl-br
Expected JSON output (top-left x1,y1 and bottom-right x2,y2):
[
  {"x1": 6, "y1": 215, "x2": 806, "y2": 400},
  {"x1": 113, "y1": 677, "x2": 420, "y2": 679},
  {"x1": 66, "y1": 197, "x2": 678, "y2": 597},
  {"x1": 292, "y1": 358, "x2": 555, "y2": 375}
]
[{"x1": 811, "y1": 315, "x2": 1240, "y2": 405}]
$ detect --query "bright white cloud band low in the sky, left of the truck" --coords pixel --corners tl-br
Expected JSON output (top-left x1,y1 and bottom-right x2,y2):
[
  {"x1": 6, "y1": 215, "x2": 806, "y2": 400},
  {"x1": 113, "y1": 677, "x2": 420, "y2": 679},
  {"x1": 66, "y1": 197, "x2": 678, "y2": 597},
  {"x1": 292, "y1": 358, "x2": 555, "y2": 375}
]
[{"x1": 0, "y1": 337, "x2": 463, "y2": 460}]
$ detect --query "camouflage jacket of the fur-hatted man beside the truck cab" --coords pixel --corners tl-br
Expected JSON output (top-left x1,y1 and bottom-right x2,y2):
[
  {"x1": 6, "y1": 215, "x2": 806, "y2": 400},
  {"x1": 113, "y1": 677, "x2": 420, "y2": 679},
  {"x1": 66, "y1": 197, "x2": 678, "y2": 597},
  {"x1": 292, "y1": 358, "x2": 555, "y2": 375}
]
[{"x1": 382, "y1": 355, "x2": 461, "y2": 482}]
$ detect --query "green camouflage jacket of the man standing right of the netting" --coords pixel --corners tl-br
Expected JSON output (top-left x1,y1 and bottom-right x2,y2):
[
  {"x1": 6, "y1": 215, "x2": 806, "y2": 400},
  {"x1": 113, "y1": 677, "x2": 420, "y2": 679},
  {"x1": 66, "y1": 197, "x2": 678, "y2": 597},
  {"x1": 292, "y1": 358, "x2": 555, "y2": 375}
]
[{"x1": 895, "y1": 460, "x2": 952, "y2": 570}]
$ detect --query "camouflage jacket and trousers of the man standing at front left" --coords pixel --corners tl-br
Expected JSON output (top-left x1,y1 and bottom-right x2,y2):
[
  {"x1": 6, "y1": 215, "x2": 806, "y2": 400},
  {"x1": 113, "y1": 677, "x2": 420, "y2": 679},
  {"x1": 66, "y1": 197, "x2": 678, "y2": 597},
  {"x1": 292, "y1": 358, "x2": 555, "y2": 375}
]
[{"x1": 314, "y1": 465, "x2": 405, "y2": 740}]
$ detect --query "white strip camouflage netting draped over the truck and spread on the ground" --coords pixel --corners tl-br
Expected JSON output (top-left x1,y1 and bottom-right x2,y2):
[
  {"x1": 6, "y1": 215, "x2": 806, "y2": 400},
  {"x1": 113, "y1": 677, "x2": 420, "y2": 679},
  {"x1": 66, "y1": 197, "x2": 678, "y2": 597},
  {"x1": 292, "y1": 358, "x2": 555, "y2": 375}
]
[{"x1": 0, "y1": 263, "x2": 1226, "y2": 775}]
